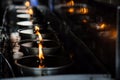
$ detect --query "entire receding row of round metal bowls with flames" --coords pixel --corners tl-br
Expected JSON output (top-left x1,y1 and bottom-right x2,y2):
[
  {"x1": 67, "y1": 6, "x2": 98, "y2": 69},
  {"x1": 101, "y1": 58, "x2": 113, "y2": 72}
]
[{"x1": 6, "y1": 1, "x2": 72, "y2": 76}]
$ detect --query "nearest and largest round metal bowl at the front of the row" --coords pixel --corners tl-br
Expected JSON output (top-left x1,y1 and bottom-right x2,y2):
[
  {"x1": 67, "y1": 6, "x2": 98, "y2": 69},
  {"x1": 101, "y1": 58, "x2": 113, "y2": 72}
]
[{"x1": 15, "y1": 56, "x2": 72, "y2": 76}]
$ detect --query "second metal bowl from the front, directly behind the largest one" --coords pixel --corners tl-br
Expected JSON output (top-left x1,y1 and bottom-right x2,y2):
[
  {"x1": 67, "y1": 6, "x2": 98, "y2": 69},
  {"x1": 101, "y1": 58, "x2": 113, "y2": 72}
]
[{"x1": 19, "y1": 40, "x2": 62, "y2": 56}]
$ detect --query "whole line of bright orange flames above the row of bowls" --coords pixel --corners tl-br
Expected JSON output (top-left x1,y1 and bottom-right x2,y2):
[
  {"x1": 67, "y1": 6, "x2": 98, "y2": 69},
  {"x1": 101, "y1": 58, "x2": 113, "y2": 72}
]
[{"x1": 24, "y1": 0, "x2": 44, "y2": 68}]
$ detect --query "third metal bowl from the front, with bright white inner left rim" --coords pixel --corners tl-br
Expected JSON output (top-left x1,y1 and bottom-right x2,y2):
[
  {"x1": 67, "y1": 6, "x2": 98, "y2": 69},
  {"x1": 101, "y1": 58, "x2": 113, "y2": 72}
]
[{"x1": 18, "y1": 29, "x2": 59, "y2": 41}]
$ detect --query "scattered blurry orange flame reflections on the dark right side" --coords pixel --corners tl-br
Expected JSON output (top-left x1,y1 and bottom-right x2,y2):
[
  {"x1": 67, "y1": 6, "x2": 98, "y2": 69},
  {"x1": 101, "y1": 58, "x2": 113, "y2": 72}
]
[{"x1": 66, "y1": 0, "x2": 117, "y2": 39}]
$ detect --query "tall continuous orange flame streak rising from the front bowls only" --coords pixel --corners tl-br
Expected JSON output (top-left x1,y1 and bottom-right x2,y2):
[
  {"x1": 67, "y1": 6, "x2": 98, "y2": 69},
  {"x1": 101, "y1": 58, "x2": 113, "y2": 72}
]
[{"x1": 35, "y1": 26, "x2": 44, "y2": 68}]
